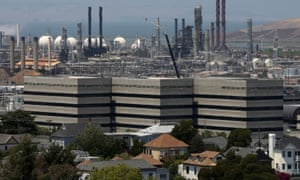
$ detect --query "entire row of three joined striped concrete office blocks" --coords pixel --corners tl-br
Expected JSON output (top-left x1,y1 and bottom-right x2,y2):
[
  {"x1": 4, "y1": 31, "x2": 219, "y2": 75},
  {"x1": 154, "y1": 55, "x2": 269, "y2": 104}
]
[{"x1": 24, "y1": 76, "x2": 283, "y2": 136}]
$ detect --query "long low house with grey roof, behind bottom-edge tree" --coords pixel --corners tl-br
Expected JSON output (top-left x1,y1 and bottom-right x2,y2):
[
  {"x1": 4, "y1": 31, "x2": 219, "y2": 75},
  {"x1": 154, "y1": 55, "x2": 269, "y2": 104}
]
[{"x1": 77, "y1": 159, "x2": 169, "y2": 180}]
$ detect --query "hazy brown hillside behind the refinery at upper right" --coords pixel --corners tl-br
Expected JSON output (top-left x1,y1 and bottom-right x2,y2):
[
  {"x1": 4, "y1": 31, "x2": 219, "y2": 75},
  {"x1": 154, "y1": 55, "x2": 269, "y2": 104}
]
[{"x1": 226, "y1": 18, "x2": 300, "y2": 41}]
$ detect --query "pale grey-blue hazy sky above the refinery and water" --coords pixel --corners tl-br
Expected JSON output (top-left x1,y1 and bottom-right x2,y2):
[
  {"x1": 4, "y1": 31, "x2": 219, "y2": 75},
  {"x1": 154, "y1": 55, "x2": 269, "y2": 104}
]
[{"x1": 0, "y1": 0, "x2": 300, "y2": 35}]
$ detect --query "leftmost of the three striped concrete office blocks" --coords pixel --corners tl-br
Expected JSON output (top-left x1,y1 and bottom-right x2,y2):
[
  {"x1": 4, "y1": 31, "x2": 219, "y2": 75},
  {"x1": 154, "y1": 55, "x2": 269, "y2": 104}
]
[{"x1": 24, "y1": 76, "x2": 111, "y2": 129}]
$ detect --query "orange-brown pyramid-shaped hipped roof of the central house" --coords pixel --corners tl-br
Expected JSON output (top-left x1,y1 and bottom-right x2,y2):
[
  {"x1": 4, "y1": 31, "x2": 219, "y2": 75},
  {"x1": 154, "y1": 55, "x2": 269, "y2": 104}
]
[{"x1": 144, "y1": 134, "x2": 189, "y2": 148}]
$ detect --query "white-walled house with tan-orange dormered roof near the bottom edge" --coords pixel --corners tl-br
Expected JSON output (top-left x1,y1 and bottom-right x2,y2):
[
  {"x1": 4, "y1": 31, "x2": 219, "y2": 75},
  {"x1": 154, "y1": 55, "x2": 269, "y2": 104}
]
[{"x1": 178, "y1": 151, "x2": 225, "y2": 180}]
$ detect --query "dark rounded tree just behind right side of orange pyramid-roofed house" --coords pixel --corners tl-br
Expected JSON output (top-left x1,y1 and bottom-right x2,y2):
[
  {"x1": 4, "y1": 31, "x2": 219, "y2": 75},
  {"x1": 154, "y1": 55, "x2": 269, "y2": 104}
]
[{"x1": 171, "y1": 120, "x2": 198, "y2": 144}]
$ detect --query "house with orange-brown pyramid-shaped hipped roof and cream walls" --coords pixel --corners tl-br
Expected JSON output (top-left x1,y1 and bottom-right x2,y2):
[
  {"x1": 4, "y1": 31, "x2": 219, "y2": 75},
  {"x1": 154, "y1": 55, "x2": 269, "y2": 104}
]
[{"x1": 144, "y1": 134, "x2": 188, "y2": 161}]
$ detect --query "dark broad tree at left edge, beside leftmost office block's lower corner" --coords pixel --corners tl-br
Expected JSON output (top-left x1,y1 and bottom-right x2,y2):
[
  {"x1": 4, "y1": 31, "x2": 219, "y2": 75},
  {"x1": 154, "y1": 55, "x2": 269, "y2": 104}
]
[{"x1": 0, "y1": 110, "x2": 38, "y2": 134}]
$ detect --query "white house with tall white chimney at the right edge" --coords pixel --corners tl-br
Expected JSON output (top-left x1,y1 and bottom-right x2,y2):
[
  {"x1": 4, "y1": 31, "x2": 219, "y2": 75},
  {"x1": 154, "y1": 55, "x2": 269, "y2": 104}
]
[{"x1": 268, "y1": 134, "x2": 300, "y2": 175}]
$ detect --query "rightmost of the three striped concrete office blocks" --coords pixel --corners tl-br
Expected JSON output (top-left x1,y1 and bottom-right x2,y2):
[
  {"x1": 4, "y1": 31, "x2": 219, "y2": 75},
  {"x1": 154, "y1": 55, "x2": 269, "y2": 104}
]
[{"x1": 194, "y1": 77, "x2": 283, "y2": 135}]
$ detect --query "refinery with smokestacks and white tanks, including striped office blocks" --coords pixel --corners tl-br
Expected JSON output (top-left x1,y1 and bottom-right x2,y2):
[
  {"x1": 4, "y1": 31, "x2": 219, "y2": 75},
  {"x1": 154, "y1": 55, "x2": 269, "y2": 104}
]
[{"x1": 0, "y1": 0, "x2": 300, "y2": 136}]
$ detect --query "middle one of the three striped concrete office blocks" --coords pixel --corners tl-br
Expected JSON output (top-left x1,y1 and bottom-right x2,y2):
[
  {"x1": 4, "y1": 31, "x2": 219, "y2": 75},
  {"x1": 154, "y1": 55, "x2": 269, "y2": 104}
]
[{"x1": 112, "y1": 78, "x2": 193, "y2": 131}]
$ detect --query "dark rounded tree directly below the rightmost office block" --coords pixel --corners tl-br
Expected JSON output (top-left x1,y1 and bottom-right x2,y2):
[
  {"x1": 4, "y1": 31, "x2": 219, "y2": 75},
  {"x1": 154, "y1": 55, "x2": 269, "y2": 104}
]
[{"x1": 226, "y1": 129, "x2": 252, "y2": 149}]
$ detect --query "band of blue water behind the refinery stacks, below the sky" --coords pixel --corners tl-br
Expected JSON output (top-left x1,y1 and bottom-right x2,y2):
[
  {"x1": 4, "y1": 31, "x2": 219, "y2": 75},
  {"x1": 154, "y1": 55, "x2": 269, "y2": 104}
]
[{"x1": 0, "y1": 21, "x2": 260, "y2": 42}]
